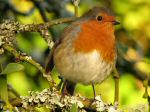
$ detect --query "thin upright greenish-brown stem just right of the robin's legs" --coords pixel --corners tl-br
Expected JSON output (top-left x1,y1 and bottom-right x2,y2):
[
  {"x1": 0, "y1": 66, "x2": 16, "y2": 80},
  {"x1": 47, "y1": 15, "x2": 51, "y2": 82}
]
[{"x1": 114, "y1": 68, "x2": 119, "y2": 104}]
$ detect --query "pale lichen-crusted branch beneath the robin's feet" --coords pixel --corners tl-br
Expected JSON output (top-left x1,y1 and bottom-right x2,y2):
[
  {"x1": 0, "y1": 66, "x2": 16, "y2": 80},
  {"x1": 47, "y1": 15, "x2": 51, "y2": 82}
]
[{"x1": 21, "y1": 88, "x2": 117, "y2": 111}]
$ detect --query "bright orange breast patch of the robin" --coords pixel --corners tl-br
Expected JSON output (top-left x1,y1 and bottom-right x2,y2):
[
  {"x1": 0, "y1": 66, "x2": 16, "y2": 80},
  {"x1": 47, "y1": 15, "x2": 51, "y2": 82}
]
[{"x1": 74, "y1": 20, "x2": 116, "y2": 62}]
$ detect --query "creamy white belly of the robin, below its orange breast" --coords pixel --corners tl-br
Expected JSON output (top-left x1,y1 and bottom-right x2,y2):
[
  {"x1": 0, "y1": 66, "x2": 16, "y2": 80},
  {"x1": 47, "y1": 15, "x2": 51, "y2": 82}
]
[{"x1": 54, "y1": 47, "x2": 114, "y2": 84}]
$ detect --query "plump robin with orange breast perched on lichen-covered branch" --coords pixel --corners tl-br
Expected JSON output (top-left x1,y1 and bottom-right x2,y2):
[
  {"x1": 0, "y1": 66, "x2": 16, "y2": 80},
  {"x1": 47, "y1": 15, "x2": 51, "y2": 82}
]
[{"x1": 45, "y1": 7, "x2": 119, "y2": 97}]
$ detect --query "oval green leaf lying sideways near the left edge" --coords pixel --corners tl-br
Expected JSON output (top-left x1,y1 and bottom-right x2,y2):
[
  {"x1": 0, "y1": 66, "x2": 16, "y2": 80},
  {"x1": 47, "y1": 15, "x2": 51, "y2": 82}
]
[{"x1": 1, "y1": 63, "x2": 24, "y2": 74}]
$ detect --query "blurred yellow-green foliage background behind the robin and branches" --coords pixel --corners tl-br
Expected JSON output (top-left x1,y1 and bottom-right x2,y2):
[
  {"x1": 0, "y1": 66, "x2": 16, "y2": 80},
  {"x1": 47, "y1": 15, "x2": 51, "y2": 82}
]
[{"x1": 0, "y1": 0, "x2": 150, "y2": 110}]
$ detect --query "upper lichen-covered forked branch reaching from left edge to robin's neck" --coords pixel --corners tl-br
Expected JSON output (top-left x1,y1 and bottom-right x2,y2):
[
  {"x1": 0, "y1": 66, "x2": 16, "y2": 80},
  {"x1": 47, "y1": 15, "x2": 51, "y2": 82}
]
[{"x1": 0, "y1": 17, "x2": 76, "y2": 48}]
